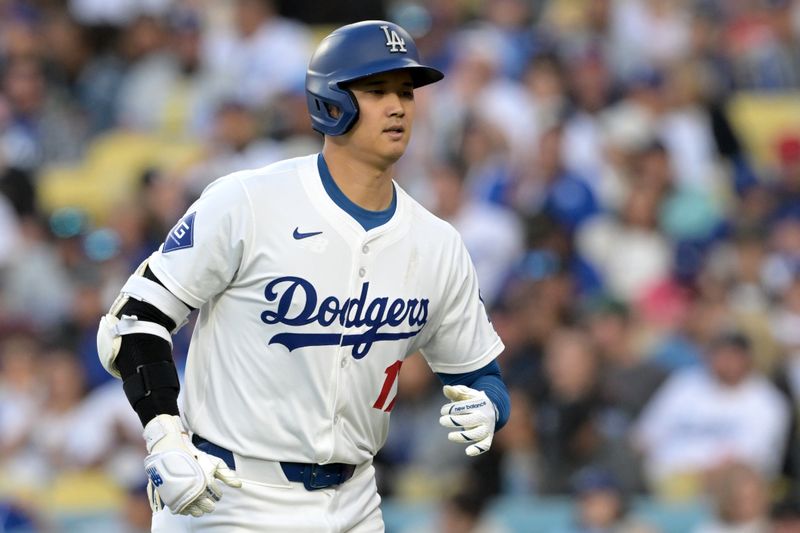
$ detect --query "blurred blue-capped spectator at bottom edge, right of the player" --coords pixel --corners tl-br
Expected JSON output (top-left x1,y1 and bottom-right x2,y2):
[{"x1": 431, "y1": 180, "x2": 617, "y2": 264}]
[{"x1": 561, "y1": 468, "x2": 656, "y2": 533}]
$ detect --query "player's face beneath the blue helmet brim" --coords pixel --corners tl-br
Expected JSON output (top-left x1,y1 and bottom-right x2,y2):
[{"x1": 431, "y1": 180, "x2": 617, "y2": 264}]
[{"x1": 347, "y1": 71, "x2": 414, "y2": 163}]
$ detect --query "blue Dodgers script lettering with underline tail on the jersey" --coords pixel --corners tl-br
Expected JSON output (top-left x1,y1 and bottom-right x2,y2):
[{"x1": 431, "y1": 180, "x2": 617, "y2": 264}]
[{"x1": 261, "y1": 276, "x2": 428, "y2": 359}]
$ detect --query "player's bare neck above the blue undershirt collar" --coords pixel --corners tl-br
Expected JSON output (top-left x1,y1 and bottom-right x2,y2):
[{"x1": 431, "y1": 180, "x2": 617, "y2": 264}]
[{"x1": 322, "y1": 145, "x2": 394, "y2": 211}]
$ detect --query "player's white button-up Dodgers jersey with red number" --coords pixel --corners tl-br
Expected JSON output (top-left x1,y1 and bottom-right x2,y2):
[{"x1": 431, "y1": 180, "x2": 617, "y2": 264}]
[{"x1": 149, "y1": 155, "x2": 503, "y2": 464}]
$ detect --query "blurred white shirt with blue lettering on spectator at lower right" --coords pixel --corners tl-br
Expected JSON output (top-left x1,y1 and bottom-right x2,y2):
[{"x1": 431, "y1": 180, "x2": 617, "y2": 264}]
[{"x1": 634, "y1": 369, "x2": 789, "y2": 483}]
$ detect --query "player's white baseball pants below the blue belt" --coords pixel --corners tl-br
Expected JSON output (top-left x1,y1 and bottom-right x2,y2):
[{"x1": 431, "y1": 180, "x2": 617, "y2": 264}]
[{"x1": 152, "y1": 462, "x2": 384, "y2": 533}]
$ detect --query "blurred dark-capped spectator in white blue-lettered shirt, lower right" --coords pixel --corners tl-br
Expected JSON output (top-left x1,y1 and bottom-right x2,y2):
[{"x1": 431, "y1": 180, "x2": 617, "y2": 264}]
[{"x1": 635, "y1": 332, "x2": 789, "y2": 498}]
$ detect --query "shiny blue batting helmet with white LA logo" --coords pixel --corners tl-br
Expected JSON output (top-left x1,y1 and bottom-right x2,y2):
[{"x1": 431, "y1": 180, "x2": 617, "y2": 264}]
[{"x1": 306, "y1": 20, "x2": 444, "y2": 135}]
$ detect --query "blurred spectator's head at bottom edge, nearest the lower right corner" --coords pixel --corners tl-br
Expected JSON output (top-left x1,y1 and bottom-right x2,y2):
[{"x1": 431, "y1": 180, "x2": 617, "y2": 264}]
[{"x1": 693, "y1": 463, "x2": 770, "y2": 533}]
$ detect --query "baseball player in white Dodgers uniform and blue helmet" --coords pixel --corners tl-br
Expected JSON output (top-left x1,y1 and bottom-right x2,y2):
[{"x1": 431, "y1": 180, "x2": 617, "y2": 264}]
[{"x1": 98, "y1": 21, "x2": 510, "y2": 533}]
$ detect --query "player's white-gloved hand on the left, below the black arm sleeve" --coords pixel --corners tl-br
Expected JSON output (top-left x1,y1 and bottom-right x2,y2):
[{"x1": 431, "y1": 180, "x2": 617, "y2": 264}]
[{"x1": 143, "y1": 415, "x2": 242, "y2": 516}]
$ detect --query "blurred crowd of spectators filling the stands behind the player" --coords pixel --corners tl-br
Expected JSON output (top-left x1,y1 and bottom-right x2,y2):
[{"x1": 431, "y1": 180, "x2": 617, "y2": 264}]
[{"x1": 0, "y1": 0, "x2": 800, "y2": 533}]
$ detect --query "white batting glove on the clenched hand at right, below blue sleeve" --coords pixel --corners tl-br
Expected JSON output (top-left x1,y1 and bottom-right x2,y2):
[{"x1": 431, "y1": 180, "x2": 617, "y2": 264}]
[{"x1": 439, "y1": 385, "x2": 497, "y2": 457}]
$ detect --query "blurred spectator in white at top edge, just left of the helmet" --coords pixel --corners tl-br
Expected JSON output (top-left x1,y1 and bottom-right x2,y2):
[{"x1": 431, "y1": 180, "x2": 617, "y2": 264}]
[{"x1": 204, "y1": 0, "x2": 312, "y2": 109}]
